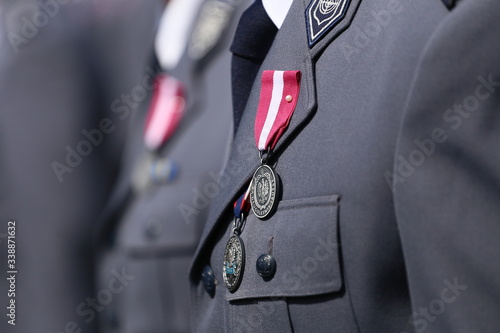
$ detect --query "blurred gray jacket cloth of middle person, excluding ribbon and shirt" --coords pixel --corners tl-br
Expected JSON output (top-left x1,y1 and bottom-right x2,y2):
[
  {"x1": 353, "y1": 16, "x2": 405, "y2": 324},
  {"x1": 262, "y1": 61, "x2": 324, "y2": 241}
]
[{"x1": 97, "y1": 0, "x2": 247, "y2": 333}]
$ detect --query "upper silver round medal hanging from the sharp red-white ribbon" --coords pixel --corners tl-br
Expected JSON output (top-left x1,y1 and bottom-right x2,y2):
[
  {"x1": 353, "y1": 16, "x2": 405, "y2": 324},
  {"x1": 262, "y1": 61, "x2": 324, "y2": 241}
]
[{"x1": 250, "y1": 164, "x2": 279, "y2": 219}]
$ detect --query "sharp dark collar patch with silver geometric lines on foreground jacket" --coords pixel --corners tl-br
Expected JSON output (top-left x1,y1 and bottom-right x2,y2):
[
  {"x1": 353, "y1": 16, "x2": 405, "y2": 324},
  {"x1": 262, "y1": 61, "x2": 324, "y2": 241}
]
[{"x1": 306, "y1": 0, "x2": 351, "y2": 47}]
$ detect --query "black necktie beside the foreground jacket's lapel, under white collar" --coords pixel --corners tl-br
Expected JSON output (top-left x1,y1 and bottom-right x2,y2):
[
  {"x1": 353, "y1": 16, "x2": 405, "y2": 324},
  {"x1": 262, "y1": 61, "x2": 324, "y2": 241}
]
[{"x1": 231, "y1": 0, "x2": 278, "y2": 133}]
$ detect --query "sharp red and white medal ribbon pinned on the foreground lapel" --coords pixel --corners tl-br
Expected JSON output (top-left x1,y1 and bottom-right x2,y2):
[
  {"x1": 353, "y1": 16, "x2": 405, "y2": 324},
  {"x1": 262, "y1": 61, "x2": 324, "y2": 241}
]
[{"x1": 255, "y1": 71, "x2": 301, "y2": 151}]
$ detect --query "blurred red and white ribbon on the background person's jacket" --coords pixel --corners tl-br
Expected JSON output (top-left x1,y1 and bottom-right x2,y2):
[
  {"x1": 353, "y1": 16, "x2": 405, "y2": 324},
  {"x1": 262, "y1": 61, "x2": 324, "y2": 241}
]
[{"x1": 144, "y1": 74, "x2": 186, "y2": 150}]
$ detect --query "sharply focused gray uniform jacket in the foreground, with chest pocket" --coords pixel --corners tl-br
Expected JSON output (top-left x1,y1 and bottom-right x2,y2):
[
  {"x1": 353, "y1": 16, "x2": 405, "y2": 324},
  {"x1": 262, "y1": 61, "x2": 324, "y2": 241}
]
[{"x1": 190, "y1": 0, "x2": 500, "y2": 333}]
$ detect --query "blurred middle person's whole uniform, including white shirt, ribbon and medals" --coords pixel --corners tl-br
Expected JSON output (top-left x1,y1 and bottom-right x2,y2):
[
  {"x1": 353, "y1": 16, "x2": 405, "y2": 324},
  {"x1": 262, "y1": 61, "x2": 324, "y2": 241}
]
[{"x1": 93, "y1": 0, "x2": 248, "y2": 333}]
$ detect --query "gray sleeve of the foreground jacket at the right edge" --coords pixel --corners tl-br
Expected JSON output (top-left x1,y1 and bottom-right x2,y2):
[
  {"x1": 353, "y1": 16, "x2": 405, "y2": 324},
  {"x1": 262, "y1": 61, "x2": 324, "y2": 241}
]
[{"x1": 392, "y1": 0, "x2": 500, "y2": 333}]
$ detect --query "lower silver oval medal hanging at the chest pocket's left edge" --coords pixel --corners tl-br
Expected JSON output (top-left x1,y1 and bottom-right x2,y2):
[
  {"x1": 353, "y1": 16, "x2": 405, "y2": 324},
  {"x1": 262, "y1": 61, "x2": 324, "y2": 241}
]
[{"x1": 222, "y1": 235, "x2": 245, "y2": 292}]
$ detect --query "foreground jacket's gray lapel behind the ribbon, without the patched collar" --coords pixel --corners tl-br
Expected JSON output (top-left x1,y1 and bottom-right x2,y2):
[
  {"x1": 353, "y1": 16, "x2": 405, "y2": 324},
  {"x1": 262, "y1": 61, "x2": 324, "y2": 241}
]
[{"x1": 191, "y1": 1, "x2": 315, "y2": 277}]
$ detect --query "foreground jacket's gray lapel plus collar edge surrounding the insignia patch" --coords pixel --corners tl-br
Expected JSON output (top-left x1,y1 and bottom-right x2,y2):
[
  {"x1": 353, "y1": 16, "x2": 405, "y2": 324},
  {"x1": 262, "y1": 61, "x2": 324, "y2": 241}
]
[{"x1": 191, "y1": 0, "x2": 360, "y2": 279}]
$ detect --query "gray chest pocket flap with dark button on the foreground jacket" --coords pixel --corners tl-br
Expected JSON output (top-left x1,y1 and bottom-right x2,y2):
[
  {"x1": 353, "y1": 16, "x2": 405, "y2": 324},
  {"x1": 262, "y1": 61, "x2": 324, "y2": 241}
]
[{"x1": 226, "y1": 195, "x2": 342, "y2": 301}]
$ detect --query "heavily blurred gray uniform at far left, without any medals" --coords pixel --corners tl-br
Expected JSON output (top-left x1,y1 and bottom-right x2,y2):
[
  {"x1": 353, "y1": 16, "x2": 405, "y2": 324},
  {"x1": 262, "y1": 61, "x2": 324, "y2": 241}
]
[{"x1": 0, "y1": 0, "x2": 162, "y2": 333}]
